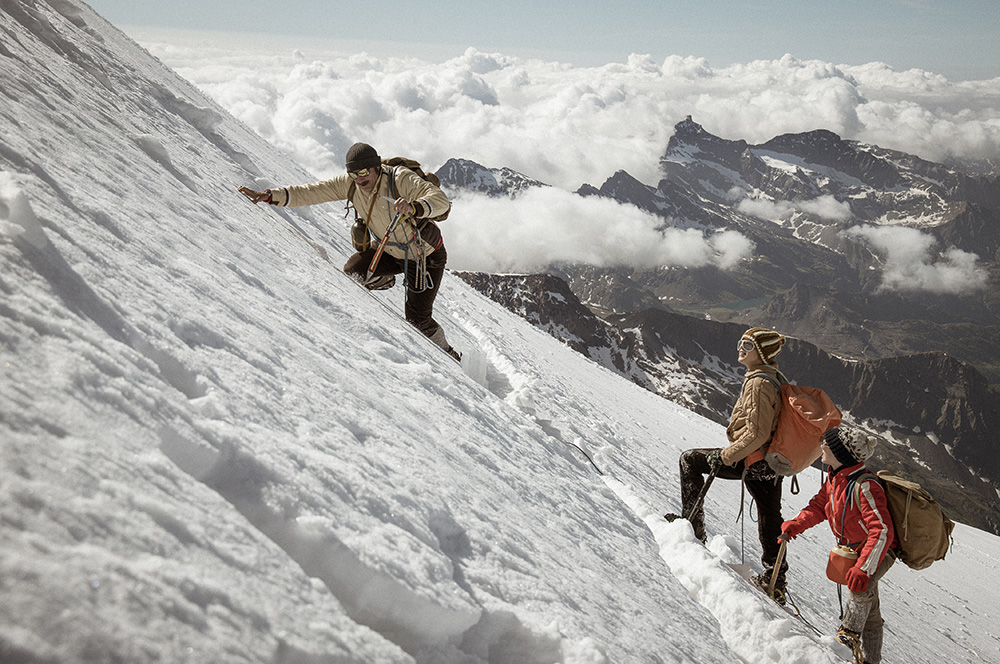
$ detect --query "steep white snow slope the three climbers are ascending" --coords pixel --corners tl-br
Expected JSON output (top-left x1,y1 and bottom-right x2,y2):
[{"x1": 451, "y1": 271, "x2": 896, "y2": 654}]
[{"x1": 0, "y1": 0, "x2": 1000, "y2": 664}]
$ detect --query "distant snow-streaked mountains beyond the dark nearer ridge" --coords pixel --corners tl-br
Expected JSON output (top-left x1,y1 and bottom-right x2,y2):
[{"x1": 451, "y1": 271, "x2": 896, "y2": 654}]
[{"x1": 438, "y1": 118, "x2": 1000, "y2": 384}]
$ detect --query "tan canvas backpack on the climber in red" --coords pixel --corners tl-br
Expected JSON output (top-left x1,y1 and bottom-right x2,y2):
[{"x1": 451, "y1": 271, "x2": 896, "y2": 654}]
[{"x1": 854, "y1": 470, "x2": 955, "y2": 570}]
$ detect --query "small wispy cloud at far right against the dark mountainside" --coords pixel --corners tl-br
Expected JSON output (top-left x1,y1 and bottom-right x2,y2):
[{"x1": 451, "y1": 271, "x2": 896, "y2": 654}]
[{"x1": 843, "y1": 225, "x2": 989, "y2": 294}]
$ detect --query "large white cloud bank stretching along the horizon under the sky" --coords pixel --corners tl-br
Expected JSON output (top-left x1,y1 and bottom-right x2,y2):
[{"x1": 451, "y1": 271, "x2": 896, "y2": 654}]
[{"x1": 145, "y1": 42, "x2": 1000, "y2": 190}]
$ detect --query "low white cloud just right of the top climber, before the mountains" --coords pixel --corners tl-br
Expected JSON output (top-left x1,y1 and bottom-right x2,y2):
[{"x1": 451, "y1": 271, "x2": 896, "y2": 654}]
[{"x1": 443, "y1": 187, "x2": 753, "y2": 272}]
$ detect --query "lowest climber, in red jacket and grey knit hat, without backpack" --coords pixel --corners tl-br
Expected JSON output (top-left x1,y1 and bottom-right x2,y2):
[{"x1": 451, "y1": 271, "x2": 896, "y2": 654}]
[{"x1": 781, "y1": 428, "x2": 899, "y2": 664}]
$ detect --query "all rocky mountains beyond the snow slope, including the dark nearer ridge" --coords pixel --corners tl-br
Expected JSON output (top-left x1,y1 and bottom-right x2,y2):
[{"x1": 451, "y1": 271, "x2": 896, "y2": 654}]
[{"x1": 438, "y1": 118, "x2": 1000, "y2": 534}]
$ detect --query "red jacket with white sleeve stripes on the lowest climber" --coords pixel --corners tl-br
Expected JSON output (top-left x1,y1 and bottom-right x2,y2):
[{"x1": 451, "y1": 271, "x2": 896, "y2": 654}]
[{"x1": 788, "y1": 463, "x2": 899, "y2": 576}]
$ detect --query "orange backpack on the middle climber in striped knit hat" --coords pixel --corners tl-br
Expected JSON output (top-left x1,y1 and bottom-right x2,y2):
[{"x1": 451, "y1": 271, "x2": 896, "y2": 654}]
[{"x1": 758, "y1": 373, "x2": 841, "y2": 476}]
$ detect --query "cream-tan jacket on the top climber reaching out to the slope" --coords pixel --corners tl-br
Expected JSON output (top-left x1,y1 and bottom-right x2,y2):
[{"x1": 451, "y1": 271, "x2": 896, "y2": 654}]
[{"x1": 271, "y1": 165, "x2": 451, "y2": 260}]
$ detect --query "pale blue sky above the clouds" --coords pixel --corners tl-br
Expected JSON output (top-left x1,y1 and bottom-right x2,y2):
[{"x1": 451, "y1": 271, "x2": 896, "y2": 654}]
[{"x1": 89, "y1": 0, "x2": 1000, "y2": 80}]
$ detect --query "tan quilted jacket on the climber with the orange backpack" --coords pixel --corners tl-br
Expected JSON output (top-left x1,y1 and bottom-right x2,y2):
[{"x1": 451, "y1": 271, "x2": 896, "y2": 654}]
[{"x1": 722, "y1": 365, "x2": 781, "y2": 466}]
